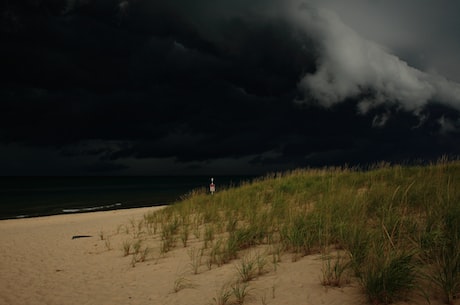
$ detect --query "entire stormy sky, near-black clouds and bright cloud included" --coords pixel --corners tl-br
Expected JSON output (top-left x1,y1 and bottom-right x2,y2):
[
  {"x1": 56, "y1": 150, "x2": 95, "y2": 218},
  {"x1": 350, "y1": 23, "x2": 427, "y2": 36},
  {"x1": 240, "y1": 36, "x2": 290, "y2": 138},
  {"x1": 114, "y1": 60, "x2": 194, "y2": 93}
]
[{"x1": 0, "y1": 0, "x2": 460, "y2": 175}]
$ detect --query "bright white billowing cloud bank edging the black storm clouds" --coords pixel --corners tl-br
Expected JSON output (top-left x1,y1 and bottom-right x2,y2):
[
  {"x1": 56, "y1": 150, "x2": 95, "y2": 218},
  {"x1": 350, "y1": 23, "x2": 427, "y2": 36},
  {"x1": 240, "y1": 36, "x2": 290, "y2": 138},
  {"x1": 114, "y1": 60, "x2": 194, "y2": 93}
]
[{"x1": 290, "y1": 5, "x2": 460, "y2": 113}]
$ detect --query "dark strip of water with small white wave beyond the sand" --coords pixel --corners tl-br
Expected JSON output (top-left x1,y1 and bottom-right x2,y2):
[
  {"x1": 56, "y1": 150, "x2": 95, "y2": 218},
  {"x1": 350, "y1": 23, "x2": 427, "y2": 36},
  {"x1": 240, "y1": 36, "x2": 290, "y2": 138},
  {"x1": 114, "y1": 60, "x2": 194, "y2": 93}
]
[{"x1": 0, "y1": 176, "x2": 253, "y2": 219}]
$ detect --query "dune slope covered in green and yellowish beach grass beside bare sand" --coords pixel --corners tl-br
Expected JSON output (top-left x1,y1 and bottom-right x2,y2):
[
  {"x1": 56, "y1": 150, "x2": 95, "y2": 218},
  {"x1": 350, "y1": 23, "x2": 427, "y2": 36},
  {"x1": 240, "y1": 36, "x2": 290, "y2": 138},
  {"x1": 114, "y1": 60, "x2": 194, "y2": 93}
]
[{"x1": 141, "y1": 161, "x2": 460, "y2": 304}]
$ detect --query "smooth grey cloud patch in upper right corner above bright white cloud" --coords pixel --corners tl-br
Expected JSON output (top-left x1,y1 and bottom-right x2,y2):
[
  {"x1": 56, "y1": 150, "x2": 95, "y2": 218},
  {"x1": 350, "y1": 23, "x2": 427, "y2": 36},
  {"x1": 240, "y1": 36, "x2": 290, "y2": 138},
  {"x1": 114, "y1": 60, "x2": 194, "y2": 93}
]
[{"x1": 300, "y1": 0, "x2": 460, "y2": 82}]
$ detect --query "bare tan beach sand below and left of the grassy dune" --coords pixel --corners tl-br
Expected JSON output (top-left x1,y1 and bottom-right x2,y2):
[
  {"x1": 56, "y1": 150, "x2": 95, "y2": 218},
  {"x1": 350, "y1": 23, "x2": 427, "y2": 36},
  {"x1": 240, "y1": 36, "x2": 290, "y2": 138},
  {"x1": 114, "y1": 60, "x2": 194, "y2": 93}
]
[{"x1": 0, "y1": 207, "x2": 440, "y2": 305}]
